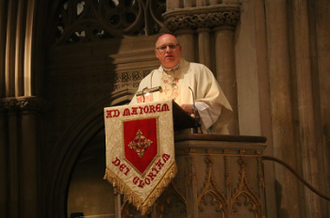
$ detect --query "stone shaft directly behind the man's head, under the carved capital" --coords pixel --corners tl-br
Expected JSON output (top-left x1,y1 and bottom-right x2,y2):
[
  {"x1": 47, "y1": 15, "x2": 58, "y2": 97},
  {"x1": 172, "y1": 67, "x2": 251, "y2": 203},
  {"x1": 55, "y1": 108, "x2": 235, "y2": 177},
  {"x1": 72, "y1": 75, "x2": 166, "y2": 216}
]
[{"x1": 175, "y1": 29, "x2": 195, "y2": 62}]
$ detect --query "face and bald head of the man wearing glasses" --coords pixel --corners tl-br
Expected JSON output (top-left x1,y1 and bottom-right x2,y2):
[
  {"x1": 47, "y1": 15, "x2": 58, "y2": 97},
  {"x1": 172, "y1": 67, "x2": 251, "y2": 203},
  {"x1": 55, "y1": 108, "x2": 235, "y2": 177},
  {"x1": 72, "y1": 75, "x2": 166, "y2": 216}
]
[{"x1": 155, "y1": 34, "x2": 182, "y2": 68}]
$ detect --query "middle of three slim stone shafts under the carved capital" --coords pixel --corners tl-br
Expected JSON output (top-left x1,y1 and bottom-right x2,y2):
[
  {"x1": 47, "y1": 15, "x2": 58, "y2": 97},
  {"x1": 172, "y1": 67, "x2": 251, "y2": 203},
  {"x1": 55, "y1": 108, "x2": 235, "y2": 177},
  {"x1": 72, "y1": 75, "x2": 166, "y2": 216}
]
[{"x1": 197, "y1": 28, "x2": 211, "y2": 69}]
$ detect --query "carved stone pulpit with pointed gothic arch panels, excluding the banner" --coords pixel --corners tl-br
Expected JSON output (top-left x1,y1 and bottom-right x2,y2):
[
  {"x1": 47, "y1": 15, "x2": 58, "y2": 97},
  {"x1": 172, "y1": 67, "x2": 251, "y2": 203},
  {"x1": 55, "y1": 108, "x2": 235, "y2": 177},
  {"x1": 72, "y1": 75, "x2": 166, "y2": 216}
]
[{"x1": 117, "y1": 134, "x2": 266, "y2": 218}]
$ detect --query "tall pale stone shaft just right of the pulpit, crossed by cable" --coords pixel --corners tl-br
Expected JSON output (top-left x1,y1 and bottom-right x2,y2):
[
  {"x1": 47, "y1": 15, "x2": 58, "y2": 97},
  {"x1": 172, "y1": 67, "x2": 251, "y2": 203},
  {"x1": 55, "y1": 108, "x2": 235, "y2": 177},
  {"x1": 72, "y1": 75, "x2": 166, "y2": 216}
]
[{"x1": 266, "y1": 0, "x2": 301, "y2": 217}]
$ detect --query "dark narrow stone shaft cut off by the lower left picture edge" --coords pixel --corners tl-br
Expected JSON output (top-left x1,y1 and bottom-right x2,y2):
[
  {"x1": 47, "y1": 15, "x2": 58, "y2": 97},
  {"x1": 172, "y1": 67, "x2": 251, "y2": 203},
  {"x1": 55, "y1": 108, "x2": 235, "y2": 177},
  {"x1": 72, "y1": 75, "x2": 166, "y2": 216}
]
[{"x1": 0, "y1": 105, "x2": 8, "y2": 217}]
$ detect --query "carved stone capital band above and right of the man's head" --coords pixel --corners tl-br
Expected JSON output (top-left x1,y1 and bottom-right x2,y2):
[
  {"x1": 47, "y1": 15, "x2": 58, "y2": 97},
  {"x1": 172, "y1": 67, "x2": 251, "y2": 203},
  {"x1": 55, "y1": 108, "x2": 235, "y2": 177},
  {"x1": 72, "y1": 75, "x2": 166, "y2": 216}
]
[{"x1": 163, "y1": 5, "x2": 240, "y2": 32}]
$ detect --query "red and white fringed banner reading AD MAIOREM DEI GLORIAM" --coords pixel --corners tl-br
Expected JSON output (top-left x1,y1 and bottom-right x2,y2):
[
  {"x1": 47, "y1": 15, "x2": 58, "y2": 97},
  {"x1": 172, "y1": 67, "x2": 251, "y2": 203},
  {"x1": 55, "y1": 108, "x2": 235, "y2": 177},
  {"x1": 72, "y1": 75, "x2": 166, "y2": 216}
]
[{"x1": 104, "y1": 100, "x2": 177, "y2": 215}]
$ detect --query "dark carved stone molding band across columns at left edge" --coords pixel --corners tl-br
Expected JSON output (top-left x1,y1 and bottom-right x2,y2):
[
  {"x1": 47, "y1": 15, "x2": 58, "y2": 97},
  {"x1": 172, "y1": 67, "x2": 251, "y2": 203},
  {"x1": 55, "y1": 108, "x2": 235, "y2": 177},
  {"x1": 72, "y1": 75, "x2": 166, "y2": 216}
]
[{"x1": 0, "y1": 97, "x2": 45, "y2": 113}]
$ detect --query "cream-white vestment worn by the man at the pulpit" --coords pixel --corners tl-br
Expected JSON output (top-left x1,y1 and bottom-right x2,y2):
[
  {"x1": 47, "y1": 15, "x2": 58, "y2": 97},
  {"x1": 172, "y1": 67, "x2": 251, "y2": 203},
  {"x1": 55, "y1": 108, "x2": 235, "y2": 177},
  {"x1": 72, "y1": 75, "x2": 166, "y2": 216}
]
[{"x1": 130, "y1": 59, "x2": 232, "y2": 134}]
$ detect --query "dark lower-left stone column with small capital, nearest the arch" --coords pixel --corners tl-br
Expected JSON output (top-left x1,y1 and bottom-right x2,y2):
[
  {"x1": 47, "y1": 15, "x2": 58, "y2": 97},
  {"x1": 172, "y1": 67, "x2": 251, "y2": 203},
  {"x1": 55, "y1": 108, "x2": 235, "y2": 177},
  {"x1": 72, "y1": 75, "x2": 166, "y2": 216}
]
[{"x1": 18, "y1": 98, "x2": 39, "y2": 217}]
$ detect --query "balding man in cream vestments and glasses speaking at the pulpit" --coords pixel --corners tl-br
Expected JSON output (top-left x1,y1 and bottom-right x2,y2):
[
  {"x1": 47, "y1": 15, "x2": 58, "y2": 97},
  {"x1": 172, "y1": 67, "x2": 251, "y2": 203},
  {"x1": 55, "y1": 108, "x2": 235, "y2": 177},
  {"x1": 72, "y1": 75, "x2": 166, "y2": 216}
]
[{"x1": 130, "y1": 33, "x2": 232, "y2": 134}]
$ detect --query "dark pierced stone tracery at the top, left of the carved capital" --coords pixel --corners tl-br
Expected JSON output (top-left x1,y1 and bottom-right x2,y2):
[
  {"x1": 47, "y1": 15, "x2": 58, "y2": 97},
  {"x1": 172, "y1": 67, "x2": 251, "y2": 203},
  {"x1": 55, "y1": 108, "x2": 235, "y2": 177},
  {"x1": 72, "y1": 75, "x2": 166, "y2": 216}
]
[{"x1": 56, "y1": 0, "x2": 166, "y2": 44}]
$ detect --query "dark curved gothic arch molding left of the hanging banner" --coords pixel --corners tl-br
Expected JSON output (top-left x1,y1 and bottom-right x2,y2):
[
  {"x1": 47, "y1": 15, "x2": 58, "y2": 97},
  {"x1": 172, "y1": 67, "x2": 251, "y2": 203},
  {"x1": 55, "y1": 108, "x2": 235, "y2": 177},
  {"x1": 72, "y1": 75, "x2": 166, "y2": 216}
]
[{"x1": 43, "y1": 89, "x2": 135, "y2": 217}]
